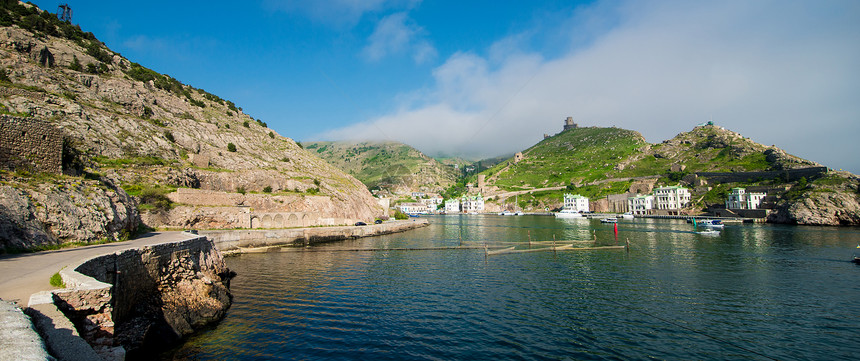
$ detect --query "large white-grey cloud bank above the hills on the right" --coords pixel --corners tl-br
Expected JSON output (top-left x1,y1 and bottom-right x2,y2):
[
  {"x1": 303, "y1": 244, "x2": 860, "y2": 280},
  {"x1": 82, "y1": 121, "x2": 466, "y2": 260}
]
[{"x1": 321, "y1": 0, "x2": 860, "y2": 173}]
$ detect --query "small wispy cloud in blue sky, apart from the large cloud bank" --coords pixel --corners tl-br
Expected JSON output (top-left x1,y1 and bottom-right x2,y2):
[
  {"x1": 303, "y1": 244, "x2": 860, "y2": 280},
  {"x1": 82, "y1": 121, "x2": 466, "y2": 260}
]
[{"x1": 362, "y1": 12, "x2": 436, "y2": 64}]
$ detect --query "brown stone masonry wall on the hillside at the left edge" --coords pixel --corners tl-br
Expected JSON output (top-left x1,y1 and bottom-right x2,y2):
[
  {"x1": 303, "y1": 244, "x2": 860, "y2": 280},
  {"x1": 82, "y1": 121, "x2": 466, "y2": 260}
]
[{"x1": 0, "y1": 115, "x2": 63, "y2": 174}]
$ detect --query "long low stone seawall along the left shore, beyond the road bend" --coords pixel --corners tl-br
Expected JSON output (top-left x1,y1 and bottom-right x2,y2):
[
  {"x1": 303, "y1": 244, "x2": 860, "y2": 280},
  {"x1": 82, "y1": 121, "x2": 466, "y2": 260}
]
[{"x1": 200, "y1": 219, "x2": 430, "y2": 253}]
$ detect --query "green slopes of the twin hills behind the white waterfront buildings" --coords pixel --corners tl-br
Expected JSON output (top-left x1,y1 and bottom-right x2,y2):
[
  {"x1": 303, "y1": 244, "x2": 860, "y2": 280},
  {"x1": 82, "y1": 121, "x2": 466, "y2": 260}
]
[{"x1": 478, "y1": 124, "x2": 818, "y2": 209}]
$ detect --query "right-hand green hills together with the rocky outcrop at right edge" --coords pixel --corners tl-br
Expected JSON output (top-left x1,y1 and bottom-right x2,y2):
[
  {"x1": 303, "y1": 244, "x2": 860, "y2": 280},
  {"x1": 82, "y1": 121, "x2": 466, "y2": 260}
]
[{"x1": 482, "y1": 124, "x2": 860, "y2": 225}]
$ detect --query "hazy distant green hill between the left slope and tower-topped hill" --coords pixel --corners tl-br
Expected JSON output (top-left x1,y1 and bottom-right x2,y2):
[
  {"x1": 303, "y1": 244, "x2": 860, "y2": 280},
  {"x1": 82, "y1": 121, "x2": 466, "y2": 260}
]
[{"x1": 303, "y1": 142, "x2": 457, "y2": 195}]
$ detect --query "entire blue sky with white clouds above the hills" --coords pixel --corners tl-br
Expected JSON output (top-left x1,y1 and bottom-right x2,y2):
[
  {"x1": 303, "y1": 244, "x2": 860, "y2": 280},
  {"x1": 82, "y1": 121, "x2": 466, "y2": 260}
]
[{"x1": 34, "y1": 0, "x2": 860, "y2": 174}]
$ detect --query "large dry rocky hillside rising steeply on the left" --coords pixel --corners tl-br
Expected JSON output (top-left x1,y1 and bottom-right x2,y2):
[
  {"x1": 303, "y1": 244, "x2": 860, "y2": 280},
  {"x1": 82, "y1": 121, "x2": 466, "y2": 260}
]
[{"x1": 0, "y1": 1, "x2": 381, "y2": 250}]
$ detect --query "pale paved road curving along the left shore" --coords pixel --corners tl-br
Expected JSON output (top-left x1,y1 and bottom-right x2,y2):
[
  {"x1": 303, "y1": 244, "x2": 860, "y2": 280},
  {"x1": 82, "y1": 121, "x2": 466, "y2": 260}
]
[{"x1": 0, "y1": 232, "x2": 189, "y2": 306}]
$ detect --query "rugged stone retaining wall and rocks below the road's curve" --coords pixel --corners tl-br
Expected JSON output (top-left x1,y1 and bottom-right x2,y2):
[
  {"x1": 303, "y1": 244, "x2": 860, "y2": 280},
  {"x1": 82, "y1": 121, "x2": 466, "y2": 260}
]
[{"x1": 54, "y1": 237, "x2": 232, "y2": 356}]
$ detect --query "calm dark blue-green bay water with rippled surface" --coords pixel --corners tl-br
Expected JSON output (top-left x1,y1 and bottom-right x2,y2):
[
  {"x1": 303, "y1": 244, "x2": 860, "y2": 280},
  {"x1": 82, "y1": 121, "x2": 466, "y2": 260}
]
[{"x1": 164, "y1": 215, "x2": 860, "y2": 360}]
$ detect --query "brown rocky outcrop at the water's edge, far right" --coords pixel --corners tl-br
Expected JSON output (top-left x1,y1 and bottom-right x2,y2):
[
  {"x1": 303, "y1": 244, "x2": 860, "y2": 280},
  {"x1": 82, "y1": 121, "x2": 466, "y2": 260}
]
[{"x1": 767, "y1": 172, "x2": 860, "y2": 226}]
